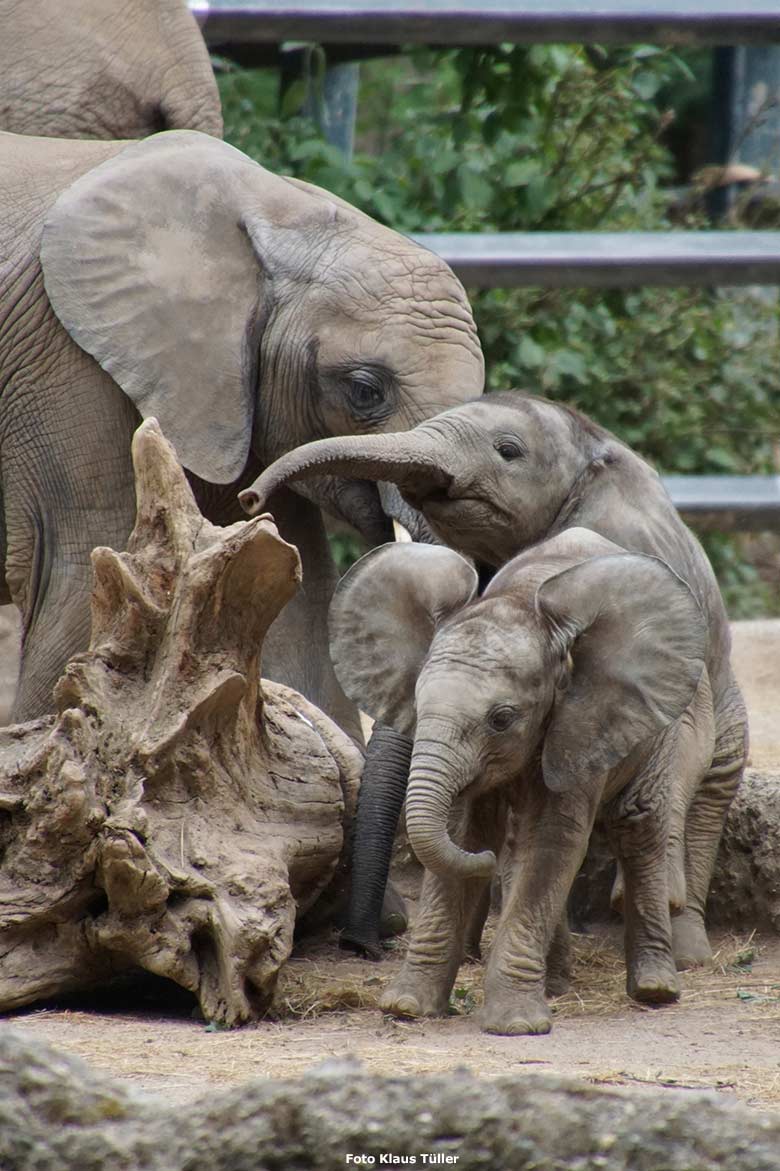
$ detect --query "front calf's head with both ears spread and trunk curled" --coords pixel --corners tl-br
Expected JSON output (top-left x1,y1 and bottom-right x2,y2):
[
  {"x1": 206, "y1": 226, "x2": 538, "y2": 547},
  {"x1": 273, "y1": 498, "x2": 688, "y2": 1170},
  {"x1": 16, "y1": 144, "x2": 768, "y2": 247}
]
[{"x1": 331, "y1": 528, "x2": 707, "y2": 877}]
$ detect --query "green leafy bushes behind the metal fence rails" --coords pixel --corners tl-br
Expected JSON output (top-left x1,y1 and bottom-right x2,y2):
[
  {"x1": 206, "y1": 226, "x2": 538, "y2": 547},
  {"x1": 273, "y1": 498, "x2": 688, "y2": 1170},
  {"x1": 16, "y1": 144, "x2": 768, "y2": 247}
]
[{"x1": 214, "y1": 46, "x2": 780, "y2": 616}]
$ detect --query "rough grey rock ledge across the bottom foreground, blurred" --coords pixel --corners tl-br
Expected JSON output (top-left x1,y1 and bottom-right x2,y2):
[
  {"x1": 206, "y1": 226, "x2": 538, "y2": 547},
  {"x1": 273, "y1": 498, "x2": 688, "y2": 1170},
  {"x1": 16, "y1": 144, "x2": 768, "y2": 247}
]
[{"x1": 0, "y1": 1030, "x2": 780, "y2": 1171}]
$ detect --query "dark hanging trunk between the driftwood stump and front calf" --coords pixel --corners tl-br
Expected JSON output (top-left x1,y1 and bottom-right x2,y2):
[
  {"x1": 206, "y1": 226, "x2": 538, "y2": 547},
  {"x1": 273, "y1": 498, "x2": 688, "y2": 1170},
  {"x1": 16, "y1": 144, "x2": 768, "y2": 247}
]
[{"x1": 341, "y1": 725, "x2": 412, "y2": 959}]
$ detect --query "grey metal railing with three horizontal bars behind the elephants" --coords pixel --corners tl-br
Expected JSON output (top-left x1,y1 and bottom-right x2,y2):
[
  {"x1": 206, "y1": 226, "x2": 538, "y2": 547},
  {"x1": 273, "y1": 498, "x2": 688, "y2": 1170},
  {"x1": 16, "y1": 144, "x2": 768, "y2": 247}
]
[{"x1": 197, "y1": 0, "x2": 780, "y2": 532}]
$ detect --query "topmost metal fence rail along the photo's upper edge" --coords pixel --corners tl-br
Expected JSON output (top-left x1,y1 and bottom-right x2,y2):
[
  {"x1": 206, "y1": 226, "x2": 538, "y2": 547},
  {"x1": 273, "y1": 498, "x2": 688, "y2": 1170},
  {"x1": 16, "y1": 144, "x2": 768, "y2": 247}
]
[{"x1": 197, "y1": 0, "x2": 780, "y2": 46}]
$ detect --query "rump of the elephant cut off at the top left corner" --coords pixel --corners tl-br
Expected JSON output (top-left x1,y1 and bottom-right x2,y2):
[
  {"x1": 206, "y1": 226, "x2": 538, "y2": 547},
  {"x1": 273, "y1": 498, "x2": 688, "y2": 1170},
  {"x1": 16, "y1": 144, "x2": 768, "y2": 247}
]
[{"x1": 0, "y1": 0, "x2": 223, "y2": 138}]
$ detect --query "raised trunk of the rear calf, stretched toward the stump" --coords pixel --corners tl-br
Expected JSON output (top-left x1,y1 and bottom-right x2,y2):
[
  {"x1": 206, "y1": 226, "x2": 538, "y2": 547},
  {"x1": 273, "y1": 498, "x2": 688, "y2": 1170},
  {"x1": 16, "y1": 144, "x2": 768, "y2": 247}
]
[{"x1": 239, "y1": 430, "x2": 453, "y2": 516}]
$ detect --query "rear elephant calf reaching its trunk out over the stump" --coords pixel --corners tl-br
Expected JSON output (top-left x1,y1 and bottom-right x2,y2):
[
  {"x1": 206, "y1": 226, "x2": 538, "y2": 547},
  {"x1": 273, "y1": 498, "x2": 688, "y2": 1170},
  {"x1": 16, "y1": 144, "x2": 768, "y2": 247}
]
[{"x1": 238, "y1": 391, "x2": 747, "y2": 967}]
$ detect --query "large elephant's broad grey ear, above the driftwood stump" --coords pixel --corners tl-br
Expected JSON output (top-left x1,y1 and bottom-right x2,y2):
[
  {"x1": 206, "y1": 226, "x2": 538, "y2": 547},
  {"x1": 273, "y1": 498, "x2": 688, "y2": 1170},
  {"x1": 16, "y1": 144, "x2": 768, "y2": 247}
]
[{"x1": 41, "y1": 130, "x2": 323, "y2": 484}]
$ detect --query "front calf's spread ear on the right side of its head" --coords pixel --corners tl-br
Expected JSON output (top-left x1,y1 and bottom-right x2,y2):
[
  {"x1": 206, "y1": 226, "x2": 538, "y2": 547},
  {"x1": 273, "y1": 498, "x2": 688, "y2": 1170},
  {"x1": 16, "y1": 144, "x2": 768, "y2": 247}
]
[{"x1": 536, "y1": 553, "x2": 707, "y2": 792}]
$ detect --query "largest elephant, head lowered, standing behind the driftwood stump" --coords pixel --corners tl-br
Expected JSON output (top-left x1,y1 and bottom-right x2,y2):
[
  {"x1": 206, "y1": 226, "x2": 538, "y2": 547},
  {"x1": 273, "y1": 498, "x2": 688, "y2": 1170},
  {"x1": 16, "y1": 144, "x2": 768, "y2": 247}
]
[{"x1": 0, "y1": 131, "x2": 484, "y2": 726}]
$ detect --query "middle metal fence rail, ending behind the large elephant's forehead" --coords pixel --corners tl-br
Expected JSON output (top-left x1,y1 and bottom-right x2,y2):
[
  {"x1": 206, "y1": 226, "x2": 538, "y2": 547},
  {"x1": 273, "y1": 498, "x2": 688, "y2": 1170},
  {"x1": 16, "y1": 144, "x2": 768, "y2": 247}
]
[{"x1": 412, "y1": 231, "x2": 780, "y2": 288}]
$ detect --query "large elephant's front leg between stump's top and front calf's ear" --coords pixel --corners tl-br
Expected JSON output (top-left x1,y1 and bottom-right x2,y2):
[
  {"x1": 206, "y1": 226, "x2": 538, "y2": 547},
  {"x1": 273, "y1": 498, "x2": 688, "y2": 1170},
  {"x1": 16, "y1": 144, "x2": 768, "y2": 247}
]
[{"x1": 261, "y1": 488, "x2": 364, "y2": 746}]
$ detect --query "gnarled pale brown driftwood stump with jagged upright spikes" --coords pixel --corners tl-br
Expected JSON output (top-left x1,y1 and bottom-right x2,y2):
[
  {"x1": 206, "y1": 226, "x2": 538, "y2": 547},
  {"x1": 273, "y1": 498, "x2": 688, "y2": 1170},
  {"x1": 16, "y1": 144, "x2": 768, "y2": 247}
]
[{"x1": 0, "y1": 419, "x2": 361, "y2": 1023}]
